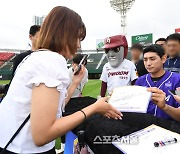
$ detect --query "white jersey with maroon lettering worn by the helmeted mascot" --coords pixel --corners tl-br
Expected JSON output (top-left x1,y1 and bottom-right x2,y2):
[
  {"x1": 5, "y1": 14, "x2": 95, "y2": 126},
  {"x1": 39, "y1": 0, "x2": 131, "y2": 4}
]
[{"x1": 100, "y1": 59, "x2": 137, "y2": 93}]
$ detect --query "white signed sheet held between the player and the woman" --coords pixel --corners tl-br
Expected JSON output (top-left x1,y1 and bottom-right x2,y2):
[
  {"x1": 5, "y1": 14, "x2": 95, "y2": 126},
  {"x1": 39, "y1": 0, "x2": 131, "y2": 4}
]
[{"x1": 109, "y1": 86, "x2": 151, "y2": 113}]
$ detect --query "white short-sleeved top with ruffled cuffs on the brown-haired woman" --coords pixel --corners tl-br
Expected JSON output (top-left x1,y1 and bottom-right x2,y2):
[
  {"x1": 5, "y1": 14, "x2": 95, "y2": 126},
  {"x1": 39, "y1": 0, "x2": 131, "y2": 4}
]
[{"x1": 0, "y1": 51, "x2": 69, "y2": 153}]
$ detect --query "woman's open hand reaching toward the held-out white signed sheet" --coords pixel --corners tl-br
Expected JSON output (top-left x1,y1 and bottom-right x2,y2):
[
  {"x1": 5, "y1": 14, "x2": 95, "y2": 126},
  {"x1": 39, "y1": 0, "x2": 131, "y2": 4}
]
[{"x1": 94, "y1": 97, "x2": 123, "y2": 120}]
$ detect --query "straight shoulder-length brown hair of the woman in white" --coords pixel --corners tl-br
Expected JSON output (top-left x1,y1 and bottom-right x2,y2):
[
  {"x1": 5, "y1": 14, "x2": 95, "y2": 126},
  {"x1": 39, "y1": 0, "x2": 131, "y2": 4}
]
[{"x1": 37, "y1": 6, "x2": 86, "y2": 55}]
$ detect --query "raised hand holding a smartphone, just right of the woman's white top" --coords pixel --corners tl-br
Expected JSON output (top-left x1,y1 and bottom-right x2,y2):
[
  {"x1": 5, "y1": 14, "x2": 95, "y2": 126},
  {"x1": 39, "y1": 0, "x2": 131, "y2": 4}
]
[{"x1": 72, "y1": 65, "x2": 85, "y2": 85}]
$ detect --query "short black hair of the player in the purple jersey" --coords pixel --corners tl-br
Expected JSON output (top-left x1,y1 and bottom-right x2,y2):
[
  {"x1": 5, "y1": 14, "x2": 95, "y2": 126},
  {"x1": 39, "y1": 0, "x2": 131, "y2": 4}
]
[{"x1": 143, "y1": 44, "x2": 165, "y2": 58}]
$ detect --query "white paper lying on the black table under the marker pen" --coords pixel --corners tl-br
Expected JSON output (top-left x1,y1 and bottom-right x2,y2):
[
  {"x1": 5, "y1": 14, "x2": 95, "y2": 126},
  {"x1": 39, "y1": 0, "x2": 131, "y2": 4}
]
[{"x1": 112, "y1": 125, "x2": 180, "y2": 154}]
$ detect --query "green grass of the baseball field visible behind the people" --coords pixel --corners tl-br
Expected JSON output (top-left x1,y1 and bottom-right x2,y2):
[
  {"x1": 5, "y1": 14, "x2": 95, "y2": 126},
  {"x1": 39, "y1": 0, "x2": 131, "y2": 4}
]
[{"x1": 0, "y1": 80, "x2": 101, "y2": 149}]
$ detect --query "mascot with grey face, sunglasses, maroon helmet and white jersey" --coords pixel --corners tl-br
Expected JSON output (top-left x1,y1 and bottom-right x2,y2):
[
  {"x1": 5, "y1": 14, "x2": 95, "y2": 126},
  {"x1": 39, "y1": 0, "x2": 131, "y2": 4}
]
[{"x1": 100, "y1": 35, "x2": 137, "y2": 97}]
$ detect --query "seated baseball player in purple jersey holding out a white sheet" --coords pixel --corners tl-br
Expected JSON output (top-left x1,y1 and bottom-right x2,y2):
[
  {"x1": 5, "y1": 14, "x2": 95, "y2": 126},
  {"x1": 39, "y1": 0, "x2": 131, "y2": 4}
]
[{"x1": 136, "y1": 45, "x2": 180, "y2": 121}]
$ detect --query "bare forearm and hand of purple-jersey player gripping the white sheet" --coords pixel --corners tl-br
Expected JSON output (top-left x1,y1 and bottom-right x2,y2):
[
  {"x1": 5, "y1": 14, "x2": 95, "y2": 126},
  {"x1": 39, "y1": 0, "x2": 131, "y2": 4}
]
[{"x1": 148, "y1": 87, "x2": 180, "y2": 122}]
